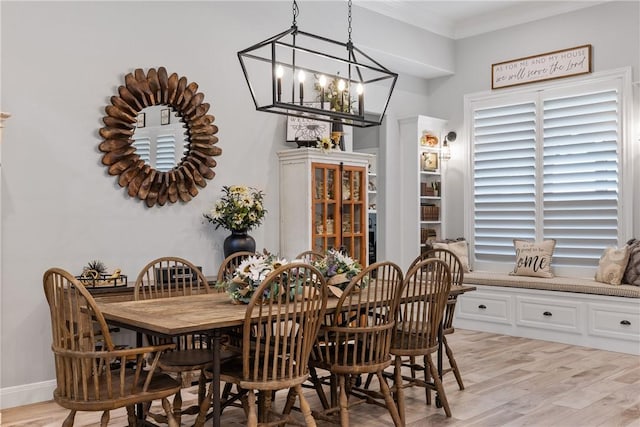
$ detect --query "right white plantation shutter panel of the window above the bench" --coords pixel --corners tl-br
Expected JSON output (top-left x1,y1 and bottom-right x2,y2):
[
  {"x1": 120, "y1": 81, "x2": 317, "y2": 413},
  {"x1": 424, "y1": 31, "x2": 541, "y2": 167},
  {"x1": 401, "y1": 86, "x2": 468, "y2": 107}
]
[{"x1": 543, "y1": 89, "x2": 621, "y2": 266}]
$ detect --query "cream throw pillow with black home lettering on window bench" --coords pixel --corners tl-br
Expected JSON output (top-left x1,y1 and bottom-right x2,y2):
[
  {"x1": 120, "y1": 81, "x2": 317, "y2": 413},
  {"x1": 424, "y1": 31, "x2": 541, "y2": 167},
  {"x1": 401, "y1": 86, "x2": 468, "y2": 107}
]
[{"x1": 509, "y1": 239, "x2": 556, "y2": 277}]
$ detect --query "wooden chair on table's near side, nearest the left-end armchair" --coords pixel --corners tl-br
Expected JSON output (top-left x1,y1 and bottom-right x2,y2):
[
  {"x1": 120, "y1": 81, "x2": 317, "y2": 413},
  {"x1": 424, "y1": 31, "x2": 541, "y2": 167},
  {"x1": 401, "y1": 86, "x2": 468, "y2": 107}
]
[{"x1": 220, "y1": 263, "x2": 327, "y2": 426}]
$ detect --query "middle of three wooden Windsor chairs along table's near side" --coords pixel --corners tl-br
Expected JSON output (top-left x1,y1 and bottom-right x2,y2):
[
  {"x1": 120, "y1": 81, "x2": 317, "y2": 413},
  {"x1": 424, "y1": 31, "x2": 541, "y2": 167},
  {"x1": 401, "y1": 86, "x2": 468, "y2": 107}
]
[{"x1": 309, "y1": 261, "x2": 403, "y2": 427}]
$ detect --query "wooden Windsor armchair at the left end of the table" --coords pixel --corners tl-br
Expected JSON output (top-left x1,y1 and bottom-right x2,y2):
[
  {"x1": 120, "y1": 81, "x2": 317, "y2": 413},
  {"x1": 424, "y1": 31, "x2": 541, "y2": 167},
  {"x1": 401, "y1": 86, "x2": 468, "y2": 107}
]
[{"x1": 43, "y1": 268, "x2": 180, "y2": 427}]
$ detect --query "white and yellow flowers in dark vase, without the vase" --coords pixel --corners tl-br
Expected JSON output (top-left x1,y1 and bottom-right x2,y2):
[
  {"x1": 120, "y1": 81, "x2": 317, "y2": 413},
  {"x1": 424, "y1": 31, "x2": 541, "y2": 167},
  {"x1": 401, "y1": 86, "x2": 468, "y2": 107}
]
[{"x1": 203, "y1": 185, "x2": 267, "y2": 231}]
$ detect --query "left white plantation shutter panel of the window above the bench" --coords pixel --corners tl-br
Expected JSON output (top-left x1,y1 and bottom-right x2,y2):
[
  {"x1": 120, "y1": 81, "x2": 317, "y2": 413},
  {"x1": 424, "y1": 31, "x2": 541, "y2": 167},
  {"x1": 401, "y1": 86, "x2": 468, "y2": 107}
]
[{"x1": 473, "y1": 101, "x2": 536, "y2": 262}]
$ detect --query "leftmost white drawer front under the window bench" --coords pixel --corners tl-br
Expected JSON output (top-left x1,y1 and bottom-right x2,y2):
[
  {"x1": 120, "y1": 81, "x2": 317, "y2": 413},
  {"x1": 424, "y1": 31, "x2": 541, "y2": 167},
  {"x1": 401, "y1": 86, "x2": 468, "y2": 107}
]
[{"x1": 457, "y1": 291, "x2": 513, "y2": 324}]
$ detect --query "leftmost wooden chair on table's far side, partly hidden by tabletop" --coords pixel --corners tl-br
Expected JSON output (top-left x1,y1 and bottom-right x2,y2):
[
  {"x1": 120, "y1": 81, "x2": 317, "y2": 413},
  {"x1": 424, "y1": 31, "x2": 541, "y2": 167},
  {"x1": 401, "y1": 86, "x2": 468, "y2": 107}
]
[{"x1": 134, "y1": 256, "x2": 234, "y2": 422}]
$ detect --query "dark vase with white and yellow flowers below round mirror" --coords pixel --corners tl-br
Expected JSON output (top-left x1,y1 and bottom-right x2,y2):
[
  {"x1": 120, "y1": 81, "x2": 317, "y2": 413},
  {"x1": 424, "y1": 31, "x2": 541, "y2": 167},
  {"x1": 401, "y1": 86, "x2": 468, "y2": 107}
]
[{"x1": 203, "y1": 185, "x2": 267, "y2": 258}]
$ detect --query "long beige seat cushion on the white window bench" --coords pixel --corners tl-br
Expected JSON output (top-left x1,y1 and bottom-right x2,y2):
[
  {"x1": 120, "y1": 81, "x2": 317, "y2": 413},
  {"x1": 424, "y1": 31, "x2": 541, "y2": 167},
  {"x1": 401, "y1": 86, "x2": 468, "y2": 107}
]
[{"x1": 463, "y1": 271, "x2": 640, "y2": 298}]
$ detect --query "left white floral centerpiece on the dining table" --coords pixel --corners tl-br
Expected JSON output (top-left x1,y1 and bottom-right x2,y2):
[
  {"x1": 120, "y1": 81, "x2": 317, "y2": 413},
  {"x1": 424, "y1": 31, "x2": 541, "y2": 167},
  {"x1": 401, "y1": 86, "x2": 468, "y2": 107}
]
[{"x1": 216, "y1": 251, "x2": 297, "y2": 304}]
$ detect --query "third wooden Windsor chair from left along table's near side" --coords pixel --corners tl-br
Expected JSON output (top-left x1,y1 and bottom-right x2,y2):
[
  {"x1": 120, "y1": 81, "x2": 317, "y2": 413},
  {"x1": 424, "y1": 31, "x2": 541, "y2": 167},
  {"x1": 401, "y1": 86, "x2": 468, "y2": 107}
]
[{"x1": 390, "y1": 258, "x2": 451, "y2": 420}]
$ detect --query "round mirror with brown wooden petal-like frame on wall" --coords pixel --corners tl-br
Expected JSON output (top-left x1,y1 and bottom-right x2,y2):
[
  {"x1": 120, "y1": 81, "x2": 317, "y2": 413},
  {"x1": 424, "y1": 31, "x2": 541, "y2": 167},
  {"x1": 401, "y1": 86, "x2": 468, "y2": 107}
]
[{"x1": 99, "y1": 67, "x2": 222, "y2": 207}]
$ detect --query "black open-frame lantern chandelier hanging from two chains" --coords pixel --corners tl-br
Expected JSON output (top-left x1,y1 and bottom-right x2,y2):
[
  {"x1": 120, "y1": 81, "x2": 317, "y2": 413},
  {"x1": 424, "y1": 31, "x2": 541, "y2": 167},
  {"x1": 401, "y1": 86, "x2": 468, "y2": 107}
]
[{"x1": 238, "y1": 0, "x2": 398, "y2": 127}]
